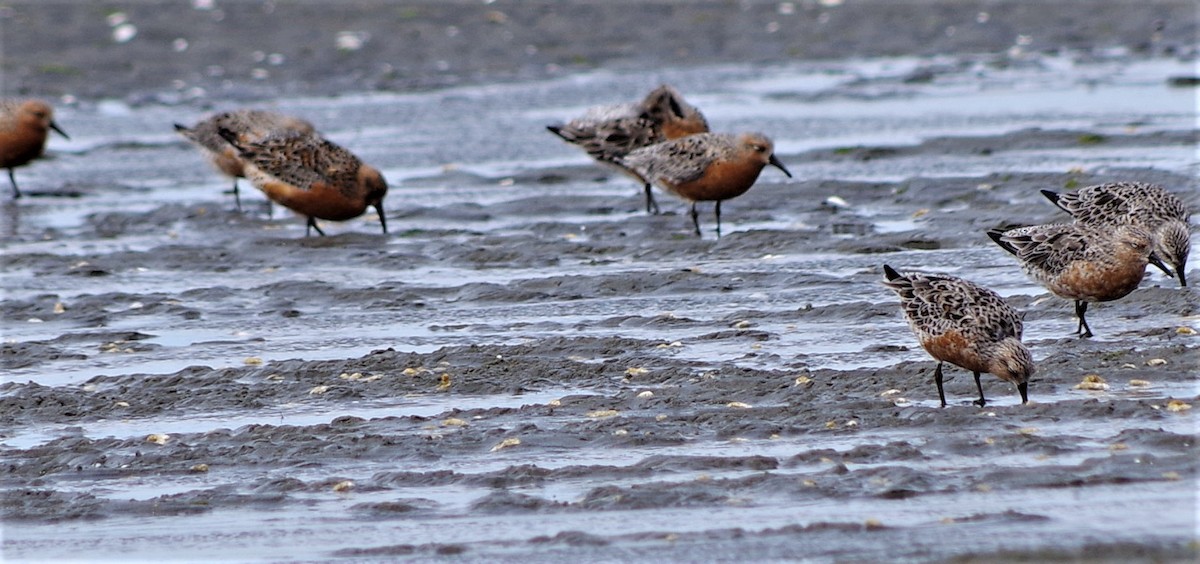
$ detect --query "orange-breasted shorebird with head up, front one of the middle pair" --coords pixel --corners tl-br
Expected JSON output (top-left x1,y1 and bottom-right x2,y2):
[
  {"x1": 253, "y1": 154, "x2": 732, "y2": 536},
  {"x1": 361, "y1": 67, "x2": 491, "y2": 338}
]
[{"x1": 619, "y1": 133, "x2": 792, "y2": 236}]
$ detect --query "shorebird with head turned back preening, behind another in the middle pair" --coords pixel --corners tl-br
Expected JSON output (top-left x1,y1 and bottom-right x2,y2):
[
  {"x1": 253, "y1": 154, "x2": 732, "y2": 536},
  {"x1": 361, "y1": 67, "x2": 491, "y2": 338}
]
[{"x1": 546, "y1": 84, "x2": 708, "y2": 214}]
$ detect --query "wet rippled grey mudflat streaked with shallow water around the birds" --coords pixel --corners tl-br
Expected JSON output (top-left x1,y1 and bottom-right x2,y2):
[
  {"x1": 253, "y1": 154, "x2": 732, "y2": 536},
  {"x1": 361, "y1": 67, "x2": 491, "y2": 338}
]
[{"x1": 0, "y1": 1, "x2": 1200, "y2": 562}]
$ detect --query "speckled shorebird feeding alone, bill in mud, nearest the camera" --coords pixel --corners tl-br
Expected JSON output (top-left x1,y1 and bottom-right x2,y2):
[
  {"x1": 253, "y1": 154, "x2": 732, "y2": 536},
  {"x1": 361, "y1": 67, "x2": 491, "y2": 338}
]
[{"x1": 883, "y1": 264, "x2": 1034, "y2": 407}]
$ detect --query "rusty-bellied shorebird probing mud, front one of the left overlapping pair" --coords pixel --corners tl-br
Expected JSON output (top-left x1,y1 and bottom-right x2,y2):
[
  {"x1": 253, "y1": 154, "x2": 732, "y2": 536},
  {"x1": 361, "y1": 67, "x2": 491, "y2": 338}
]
[{"x1": 217, "y1": 128, "x2": 388, "y2": 236}]
